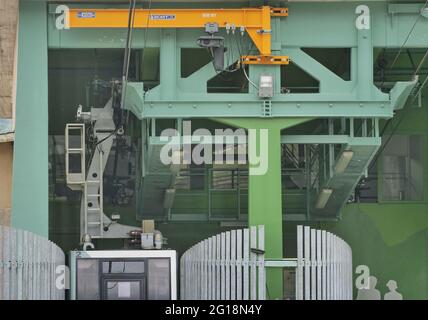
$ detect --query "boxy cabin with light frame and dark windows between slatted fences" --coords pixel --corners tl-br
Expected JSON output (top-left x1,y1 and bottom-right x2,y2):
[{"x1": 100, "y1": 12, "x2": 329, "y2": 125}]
[{"x1": 70, "y1": 250, "x2": 177, "y2": 300}]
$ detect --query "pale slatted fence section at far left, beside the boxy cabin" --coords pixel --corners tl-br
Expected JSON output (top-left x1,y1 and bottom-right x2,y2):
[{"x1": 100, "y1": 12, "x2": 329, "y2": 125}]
[{"x1": 0, "y1": 226, "x2": 64, "y2": 300}]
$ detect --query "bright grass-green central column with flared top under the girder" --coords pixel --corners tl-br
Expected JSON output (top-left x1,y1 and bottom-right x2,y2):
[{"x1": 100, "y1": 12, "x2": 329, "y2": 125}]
[{"x1": 215, "y1": 118, "x2": 310, "y2": 299}]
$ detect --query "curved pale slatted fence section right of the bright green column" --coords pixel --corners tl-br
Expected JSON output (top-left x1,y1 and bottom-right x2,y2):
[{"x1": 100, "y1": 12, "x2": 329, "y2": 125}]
[{"x1": 296, "y1": 226, "x2": 352, "y2": 300}]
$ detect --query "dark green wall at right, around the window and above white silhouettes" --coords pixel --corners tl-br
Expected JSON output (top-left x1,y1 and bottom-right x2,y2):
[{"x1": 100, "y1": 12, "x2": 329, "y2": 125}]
[{"x1": 284, "y1": 99, "x2": 428, "y2": 299}]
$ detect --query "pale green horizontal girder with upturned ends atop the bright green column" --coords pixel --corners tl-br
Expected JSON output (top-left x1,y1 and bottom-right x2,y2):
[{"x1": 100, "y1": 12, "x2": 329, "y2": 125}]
[{"x1": 126, "y1": 82, "x2": 416, "y2": 119}]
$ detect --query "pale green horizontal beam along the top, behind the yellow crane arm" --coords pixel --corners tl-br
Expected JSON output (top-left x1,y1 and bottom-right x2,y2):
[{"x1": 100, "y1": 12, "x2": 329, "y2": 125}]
[{"x1": 48, "y1": 1, "x2": 428, "y2": 48}]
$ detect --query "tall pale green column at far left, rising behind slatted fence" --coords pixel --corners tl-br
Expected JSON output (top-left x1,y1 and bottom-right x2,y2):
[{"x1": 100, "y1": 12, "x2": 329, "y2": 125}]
[{"x1": 12, "y1": 0, "x2": 49, "y2": 237}]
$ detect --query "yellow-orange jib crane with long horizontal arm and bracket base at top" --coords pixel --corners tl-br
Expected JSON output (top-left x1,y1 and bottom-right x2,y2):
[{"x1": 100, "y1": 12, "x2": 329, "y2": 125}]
[{"x1": 69, "y1": 6, "x2": 289, "y2": 65}]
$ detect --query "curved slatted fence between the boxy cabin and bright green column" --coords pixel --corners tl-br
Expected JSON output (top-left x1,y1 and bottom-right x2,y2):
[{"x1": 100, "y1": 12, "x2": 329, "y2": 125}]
[{"x1": 180, "y1": 226, "x2": 266, "y2": 300}]
